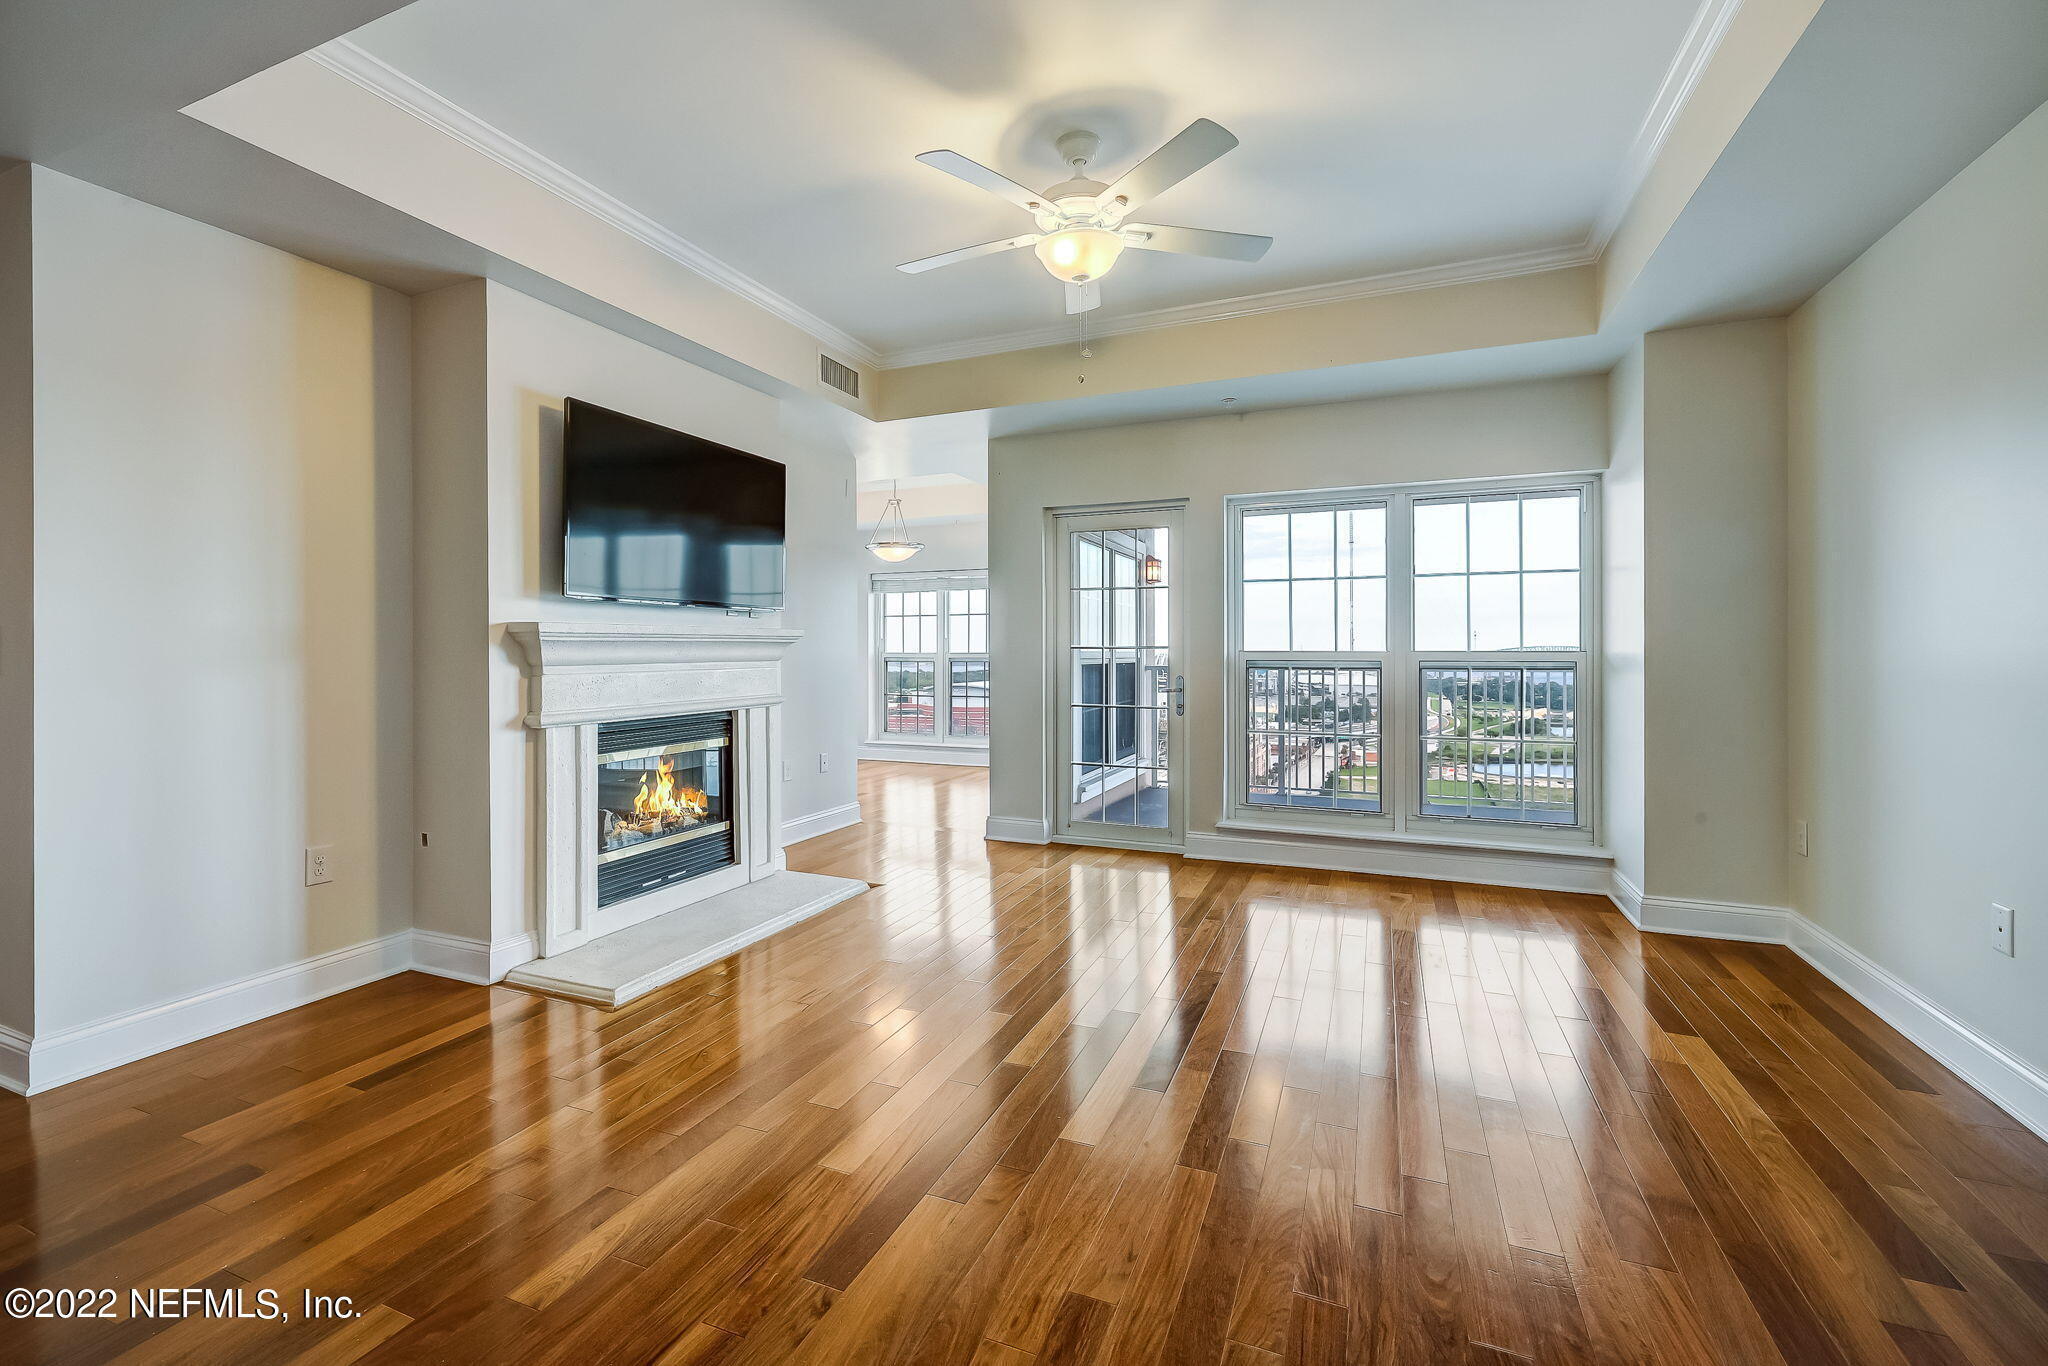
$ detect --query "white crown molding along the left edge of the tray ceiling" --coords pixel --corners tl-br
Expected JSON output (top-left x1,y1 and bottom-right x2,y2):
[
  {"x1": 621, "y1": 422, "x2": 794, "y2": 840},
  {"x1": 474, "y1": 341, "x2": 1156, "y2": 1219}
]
[{"x1": 305, "y1": 39, "x2": 881, "y2": 369}]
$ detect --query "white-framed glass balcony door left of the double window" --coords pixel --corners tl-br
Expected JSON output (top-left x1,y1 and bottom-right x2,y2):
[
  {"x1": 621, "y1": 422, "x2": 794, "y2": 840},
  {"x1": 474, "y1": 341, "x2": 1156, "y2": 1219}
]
[{"x1": 1051, "y1": 508, "x2": 1188, "y2": 850}]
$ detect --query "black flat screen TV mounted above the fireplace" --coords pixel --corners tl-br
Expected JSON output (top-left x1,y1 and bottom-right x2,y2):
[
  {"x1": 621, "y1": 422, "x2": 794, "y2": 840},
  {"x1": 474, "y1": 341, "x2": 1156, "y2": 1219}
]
[{"x1": 561, "y1": 399, "x2": 786, "y2": 610}]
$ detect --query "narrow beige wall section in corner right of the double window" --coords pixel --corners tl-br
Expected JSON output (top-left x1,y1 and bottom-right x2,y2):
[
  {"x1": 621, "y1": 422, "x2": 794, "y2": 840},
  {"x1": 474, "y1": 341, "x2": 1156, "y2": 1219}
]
[{"x1": 1642, "y1": 319, "x2": 1786, "y2": 907}]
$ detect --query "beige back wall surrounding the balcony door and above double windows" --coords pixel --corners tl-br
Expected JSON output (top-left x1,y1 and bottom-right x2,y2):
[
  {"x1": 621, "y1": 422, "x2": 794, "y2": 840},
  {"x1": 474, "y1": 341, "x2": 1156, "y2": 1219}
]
[{"x1": 989, "y1": 375, "x2": 1608, "y2": 831}]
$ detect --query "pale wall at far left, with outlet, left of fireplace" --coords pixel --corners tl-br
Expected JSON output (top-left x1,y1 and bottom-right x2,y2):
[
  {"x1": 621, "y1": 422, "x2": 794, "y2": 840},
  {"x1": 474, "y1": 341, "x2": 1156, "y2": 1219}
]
[{"x1": 35, "y1": 168, "x2": 412, "y2": 1034}]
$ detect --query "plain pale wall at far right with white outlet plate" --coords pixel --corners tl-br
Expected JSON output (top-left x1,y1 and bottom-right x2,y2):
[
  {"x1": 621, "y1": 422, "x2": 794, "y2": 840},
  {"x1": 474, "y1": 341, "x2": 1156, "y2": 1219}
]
[{"x1": 1790, "y1": 98, "x2": 2048, "y2": 1067}]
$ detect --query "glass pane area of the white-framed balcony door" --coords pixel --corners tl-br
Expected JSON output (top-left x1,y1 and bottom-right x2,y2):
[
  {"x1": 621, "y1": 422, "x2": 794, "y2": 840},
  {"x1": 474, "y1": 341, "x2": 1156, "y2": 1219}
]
[{"x1": 1063, "y1": 526, "x2": 1171, "y2": 834}]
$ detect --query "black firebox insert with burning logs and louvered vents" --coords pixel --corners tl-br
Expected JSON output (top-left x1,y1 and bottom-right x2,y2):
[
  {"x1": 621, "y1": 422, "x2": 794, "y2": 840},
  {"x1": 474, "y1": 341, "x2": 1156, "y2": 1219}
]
[{"x1": 594, "y1": 711, "x2": 739, "y2": 907}]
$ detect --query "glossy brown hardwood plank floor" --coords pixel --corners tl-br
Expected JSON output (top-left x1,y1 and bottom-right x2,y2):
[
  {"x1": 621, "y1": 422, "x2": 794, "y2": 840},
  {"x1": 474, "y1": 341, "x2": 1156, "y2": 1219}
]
[{"x1": 0, "y1": 764, "x2": 2048, "y2": 1366}]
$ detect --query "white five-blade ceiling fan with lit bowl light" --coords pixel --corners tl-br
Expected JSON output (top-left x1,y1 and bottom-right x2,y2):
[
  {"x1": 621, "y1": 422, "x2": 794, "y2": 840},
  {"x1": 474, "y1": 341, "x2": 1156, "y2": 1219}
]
[{"x1": 897, "y1": 119, "x2": 1274, "y2": 313}]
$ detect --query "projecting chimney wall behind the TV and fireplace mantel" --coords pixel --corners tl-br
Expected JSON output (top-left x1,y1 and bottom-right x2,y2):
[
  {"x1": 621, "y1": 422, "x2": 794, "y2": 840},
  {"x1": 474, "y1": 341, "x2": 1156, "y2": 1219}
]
[{"x1": 416, "y1": 281, "x2": 866, "y2": 942}]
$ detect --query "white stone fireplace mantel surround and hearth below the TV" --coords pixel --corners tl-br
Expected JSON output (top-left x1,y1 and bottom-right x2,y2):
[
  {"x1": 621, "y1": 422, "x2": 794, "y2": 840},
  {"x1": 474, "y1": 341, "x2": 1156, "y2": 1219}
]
[{"x1": 504, "y1": 621, "x2": 866, "y2": 987}]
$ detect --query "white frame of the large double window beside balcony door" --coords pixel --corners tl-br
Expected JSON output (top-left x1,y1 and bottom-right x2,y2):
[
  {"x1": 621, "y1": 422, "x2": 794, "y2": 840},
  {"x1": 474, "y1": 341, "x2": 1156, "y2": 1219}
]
[{"x1": 1217, "y1": 473, "x2": 1602, "y2": 852}]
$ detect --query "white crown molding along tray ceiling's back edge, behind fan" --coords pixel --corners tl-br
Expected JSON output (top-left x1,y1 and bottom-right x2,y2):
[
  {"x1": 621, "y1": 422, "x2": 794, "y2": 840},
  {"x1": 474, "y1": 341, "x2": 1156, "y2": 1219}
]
[{"x1": 881, "y1": 242, "x2": 1599, "y2": 369}]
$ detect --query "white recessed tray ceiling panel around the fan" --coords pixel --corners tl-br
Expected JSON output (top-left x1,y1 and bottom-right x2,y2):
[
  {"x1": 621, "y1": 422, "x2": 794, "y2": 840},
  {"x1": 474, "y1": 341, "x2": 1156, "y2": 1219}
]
[{"x1": 352, "y1": 0, "x2": 1726, "y2": 352}]
